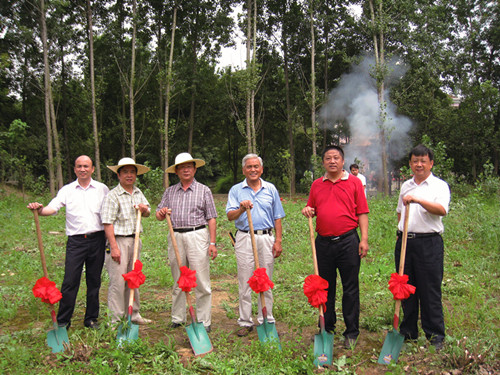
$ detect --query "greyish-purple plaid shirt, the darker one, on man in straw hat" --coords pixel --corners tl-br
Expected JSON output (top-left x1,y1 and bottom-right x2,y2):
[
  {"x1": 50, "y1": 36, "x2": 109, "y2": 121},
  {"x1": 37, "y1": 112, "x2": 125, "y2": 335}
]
[{"x1": 156, "y1": 179, "x2": 217, "y2": 229}]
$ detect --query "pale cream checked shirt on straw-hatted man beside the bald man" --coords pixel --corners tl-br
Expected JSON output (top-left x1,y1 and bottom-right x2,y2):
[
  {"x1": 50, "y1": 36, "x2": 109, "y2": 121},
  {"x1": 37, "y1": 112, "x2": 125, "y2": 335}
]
[{"x1": 101, "y1": 184, "x2": 149, "y2": 236}]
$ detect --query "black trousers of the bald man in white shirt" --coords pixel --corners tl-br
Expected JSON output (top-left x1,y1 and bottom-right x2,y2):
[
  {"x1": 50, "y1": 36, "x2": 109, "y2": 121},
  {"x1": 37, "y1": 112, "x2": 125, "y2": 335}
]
[{"x1": 57, "y1": 231, "x2": 106, "y2": 326}]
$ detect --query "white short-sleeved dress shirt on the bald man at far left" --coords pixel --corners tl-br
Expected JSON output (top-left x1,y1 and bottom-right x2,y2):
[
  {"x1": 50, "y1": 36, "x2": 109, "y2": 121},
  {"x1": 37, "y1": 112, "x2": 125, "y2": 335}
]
[{"x1": 48, "y1": 179, "x2": 109, "y2": 236}]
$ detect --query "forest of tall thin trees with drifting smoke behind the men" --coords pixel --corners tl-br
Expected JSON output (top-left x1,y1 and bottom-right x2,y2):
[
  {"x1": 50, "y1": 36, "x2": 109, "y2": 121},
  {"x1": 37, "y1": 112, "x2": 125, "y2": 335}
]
[{"x1": 0, "y1": 0, "x2": 500, "y2": 195}]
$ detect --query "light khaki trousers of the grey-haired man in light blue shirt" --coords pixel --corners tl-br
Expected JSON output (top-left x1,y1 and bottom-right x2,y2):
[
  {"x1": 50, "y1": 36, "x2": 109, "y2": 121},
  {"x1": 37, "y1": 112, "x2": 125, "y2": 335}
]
[{"x1": 234, "y1": 231, "x2": 274, "y2": 327}]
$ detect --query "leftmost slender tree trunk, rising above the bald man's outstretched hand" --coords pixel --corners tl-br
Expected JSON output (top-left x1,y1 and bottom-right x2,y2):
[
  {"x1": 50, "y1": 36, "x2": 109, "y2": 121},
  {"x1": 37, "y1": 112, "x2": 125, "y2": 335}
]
[{"x1": 40, "y1": 0, "x2": 56, "y2": 196}]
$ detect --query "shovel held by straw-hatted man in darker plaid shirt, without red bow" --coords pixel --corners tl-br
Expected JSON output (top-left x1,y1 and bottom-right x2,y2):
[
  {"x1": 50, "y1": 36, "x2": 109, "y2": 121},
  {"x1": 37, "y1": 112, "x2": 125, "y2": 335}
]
[{"x1": 166, "y1": 214, "x2": 213, "y2": 356}]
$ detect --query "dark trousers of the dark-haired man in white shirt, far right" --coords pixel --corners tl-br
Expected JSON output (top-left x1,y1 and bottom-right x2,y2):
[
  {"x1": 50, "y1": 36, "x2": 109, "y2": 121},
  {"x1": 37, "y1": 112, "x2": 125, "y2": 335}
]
[{"x1": 394, "y1": 235, "x2": 444, "y2": 343}]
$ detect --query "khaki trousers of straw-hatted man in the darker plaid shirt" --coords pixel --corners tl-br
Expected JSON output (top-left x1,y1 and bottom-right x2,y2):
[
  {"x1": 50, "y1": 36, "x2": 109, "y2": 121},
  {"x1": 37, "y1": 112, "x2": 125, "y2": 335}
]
[{"x1": 168, "y1": 228, "x2": 212, "y2": 327}]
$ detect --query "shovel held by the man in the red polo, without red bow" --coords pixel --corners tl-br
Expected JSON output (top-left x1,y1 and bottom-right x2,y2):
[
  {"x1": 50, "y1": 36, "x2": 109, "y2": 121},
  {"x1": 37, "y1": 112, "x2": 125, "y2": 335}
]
[{"x1": 309, "y1": 217, "x2": 333, "y2": 366}]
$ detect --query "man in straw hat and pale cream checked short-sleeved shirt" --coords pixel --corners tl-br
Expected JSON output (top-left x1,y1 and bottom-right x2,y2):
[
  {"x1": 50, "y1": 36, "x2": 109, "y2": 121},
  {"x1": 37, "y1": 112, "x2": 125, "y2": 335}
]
[{"x1": 101, "y1": 158, "x2": 151, "y2": 324}]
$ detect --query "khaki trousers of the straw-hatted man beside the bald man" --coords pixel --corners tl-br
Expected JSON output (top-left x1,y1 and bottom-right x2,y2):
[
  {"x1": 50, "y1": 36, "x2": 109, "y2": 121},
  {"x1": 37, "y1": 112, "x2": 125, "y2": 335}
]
[{"x1": 105, "y1": 236, "x2": 142, "y2": 323}]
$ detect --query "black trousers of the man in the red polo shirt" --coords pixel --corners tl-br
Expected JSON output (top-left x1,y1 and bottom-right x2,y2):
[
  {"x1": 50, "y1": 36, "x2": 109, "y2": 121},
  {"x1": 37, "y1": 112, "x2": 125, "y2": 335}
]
[{"x1": 316, "y1": 233, "x2": 361, "y2": 339}]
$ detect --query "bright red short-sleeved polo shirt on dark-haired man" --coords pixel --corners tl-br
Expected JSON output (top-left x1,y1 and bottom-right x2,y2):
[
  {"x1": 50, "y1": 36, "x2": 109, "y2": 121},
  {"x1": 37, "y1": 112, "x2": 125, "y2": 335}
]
[{"x1": 307, "y1": 171, "x2": 370, "y2": 237}]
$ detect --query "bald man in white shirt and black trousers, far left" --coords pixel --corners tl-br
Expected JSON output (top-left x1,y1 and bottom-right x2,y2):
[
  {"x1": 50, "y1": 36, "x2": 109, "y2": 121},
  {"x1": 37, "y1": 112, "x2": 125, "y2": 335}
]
[{"x1": 28, "y1": 155, "x2": 109, "y2": 328}]
